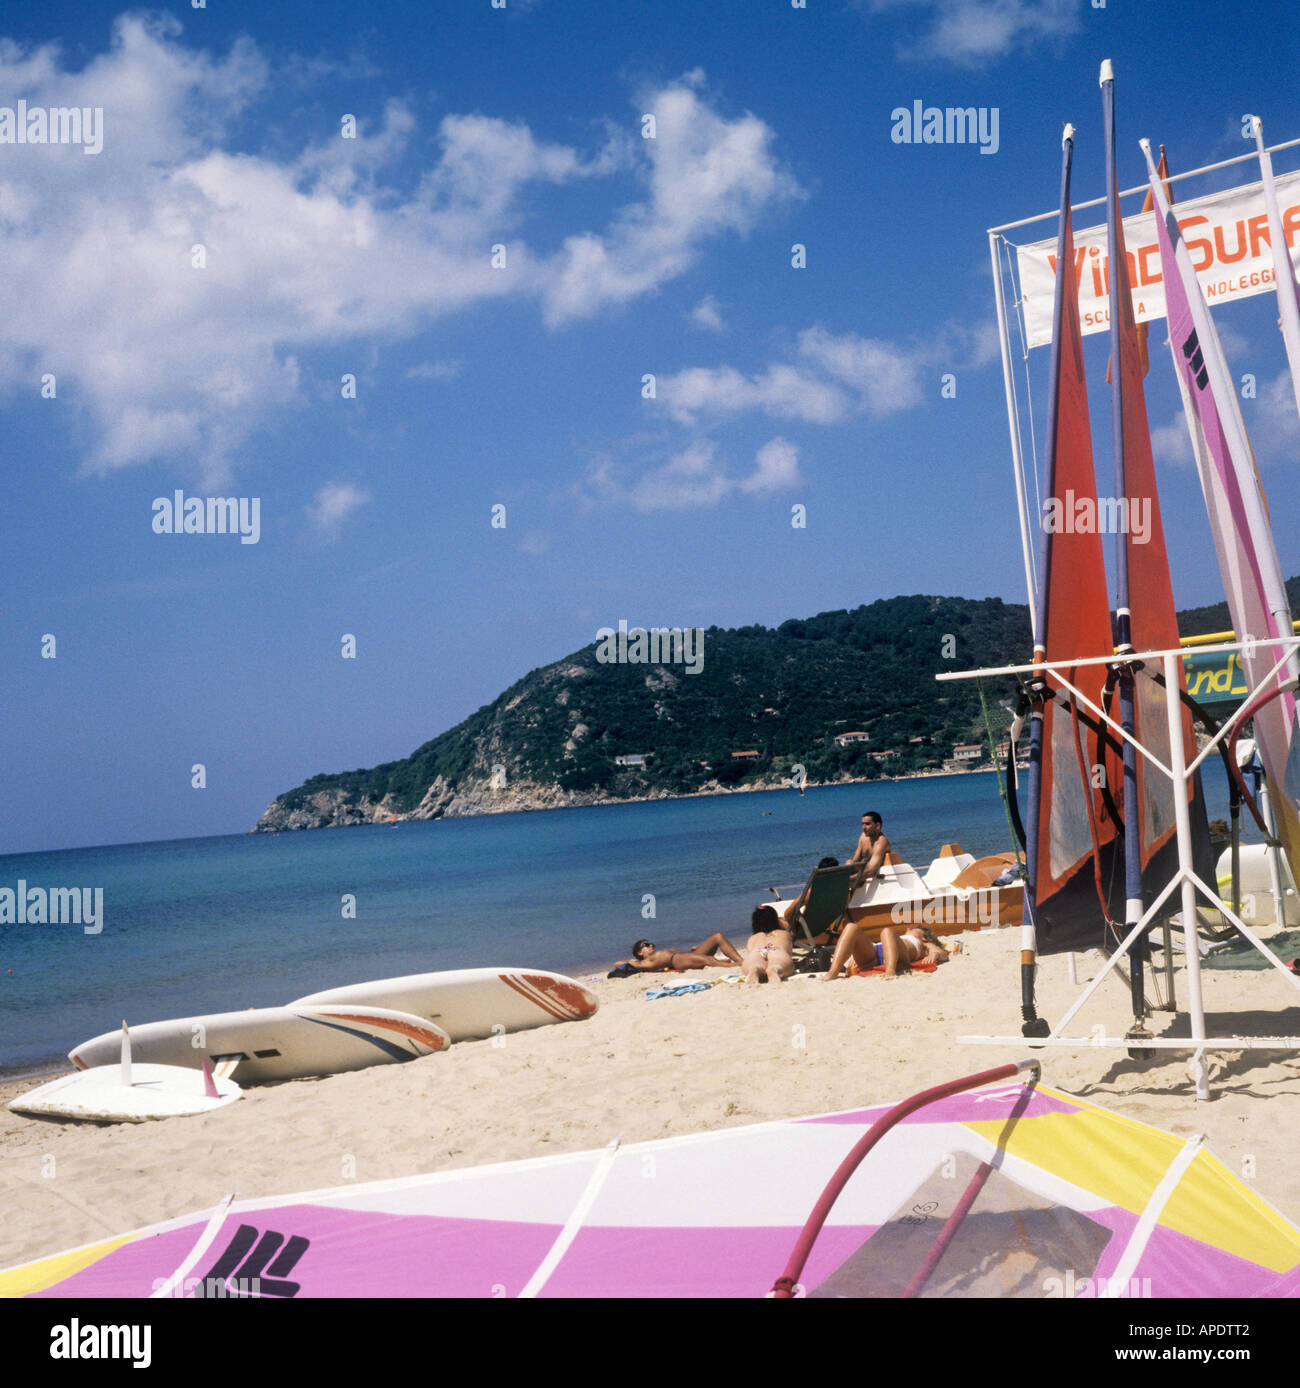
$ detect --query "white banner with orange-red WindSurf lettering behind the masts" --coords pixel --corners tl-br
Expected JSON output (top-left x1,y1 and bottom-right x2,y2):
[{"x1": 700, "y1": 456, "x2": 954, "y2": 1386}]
[{"x1": 1016, "y1": 172, "x2": 1300, "y2": 347}]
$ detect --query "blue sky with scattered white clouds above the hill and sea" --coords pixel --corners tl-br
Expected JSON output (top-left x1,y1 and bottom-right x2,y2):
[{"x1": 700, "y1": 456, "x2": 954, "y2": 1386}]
[{"x1": 0, "y1": 0, "x2": 1300, "y2": 851}]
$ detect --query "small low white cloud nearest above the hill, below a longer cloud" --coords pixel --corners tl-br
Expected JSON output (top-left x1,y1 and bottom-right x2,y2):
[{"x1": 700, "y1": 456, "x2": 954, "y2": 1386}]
[{"x1": 577, "y1": 437, "x2": 805, "y2": 512}]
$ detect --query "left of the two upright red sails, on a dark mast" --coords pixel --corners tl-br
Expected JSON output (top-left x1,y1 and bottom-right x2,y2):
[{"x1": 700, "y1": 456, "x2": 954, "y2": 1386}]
[{"x1": 1021, "y1": 125, "x2": 1115, "y2": 977}]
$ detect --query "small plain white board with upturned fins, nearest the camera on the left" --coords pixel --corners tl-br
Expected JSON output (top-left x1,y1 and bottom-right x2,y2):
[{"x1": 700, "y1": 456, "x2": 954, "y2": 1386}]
[{"x1": 10, "y1": 1065, "x2": 244, "y2": 1123}]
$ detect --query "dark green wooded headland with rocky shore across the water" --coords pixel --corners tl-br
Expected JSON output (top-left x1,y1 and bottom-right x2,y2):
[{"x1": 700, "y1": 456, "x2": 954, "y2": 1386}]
[{"x1": 257, "y1": 579, "x2": 1300, "y2": 831}]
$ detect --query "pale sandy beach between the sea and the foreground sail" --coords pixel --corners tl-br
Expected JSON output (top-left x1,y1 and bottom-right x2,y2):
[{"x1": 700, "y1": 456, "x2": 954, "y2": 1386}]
[{"x1": 0, "y1": 930, "x2": 1300, "y2": 1267}]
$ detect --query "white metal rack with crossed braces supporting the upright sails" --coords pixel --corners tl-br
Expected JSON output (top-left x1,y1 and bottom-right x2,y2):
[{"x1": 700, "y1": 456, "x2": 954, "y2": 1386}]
[{"x1": 935, "y1": 636, "x2": 1300, "y2": 1099}]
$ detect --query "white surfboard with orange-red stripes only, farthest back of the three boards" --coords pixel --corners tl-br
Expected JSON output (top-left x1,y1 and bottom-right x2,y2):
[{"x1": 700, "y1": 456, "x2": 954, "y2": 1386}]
[{"x1": 290, "y1": 969, "x2": 599, "y2": 1041}]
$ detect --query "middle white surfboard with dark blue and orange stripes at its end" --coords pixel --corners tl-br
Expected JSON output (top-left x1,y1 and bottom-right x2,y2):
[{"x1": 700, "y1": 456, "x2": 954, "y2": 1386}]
[{"x1": 68, "y1": 1005, "x2": 451, "y2": 1084}]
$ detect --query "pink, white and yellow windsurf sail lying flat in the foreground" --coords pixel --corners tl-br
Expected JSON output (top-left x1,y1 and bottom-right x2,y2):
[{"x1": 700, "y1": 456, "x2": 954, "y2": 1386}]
[{"x1": 10, "y1": 1080, "x2": 1300, "y2": 1302}]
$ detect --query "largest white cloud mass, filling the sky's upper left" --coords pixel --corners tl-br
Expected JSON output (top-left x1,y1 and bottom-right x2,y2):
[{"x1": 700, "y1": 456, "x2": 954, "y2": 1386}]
[{"x1": 0, "y1": 14, "x2": 795, "y2": 487}]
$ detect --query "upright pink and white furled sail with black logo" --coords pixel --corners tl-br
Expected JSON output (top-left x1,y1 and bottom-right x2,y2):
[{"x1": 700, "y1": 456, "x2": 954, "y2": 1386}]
[{"x1": 1143, "y1": 142, "x2": 1300, "y2": 880}]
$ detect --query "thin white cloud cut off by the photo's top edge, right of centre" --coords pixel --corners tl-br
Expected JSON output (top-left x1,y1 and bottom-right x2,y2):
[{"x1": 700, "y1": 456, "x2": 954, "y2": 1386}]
[{"x1": 857, "y1": 0, "x2": 1084, "y2": 68}]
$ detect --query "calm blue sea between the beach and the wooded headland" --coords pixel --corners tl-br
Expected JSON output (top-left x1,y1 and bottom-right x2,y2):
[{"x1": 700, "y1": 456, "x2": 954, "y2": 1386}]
[{"x1": 0, "y1": 773, "x2": 1222, "y2": 1074}]
